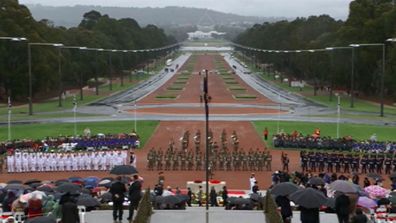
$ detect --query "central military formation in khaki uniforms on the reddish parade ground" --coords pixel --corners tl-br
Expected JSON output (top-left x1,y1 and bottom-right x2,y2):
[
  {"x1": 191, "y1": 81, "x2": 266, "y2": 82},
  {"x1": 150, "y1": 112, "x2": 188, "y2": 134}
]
[{"x1": 147, "y1": 130, "x2": 272, "y2": 172}]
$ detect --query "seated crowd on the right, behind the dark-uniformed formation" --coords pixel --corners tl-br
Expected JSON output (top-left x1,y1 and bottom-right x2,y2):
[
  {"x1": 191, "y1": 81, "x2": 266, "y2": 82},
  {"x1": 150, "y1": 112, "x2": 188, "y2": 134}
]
[{"x1": 273, "y1": 131, "x2": 396, "y2": 152}]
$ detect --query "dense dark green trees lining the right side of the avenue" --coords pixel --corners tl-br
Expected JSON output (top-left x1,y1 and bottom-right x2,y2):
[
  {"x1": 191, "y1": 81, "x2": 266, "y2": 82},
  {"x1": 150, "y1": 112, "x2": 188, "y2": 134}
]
[{"x1": 234, "y1": 0, "x2": 396, "y2": 100}]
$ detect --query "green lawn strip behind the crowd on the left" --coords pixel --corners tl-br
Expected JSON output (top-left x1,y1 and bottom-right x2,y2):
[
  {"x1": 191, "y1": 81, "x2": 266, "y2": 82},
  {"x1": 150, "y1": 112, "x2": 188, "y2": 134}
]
[{"x1": 0, "y1": 121, "x2": 159, "y2": 146}]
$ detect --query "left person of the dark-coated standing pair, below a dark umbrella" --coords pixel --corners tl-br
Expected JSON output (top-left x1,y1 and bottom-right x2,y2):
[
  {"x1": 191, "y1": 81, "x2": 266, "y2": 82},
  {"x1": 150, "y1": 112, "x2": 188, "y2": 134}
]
[{"x1": 110, "y1": 176, "x2": 126, "y2": 222}]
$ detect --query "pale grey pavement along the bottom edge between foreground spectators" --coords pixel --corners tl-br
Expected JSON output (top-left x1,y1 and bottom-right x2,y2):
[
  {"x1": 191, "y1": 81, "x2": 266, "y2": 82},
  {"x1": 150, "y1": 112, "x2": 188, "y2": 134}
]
[{"x1": 85, "y1": 207, "x2": 337, "y2": 223}]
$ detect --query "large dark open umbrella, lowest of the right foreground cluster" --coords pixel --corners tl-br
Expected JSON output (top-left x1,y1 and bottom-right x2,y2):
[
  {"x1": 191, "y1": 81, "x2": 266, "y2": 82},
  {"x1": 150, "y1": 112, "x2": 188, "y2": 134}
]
[{"x1": 290, "y1": 188, "x2": 327, "y2": 208}]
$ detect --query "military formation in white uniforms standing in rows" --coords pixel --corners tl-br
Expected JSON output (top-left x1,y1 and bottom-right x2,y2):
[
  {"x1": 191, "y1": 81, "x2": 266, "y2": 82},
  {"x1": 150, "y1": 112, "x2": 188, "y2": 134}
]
[{"x1": 6, "y1": 150, "x2": 128, "y2": 173}]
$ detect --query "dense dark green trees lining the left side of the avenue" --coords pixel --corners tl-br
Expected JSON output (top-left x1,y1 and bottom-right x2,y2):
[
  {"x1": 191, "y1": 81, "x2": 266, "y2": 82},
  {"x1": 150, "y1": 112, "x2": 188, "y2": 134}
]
[{"x1": 0, "y1": 0, "x2": 176, "y2": 102}]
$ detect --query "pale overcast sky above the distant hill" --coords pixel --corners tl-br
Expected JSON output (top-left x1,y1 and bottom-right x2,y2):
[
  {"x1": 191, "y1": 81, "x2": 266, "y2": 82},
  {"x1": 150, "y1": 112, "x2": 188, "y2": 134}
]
[{"x1": 19, "y1": 0, "x2": 351, "y2": 19}]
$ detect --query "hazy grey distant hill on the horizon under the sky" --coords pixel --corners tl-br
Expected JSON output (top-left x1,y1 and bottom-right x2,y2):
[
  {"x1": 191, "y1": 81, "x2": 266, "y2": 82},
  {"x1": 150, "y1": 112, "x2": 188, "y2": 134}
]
[{"x1": 26, "y1": 5, "x2": 280, "y2": 27}]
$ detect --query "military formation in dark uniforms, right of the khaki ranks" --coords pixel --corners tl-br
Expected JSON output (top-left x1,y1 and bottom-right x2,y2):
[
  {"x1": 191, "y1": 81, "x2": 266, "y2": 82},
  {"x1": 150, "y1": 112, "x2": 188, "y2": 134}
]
[{"x1": 300, "y1": 151, "x2": 396, "y2": 174}]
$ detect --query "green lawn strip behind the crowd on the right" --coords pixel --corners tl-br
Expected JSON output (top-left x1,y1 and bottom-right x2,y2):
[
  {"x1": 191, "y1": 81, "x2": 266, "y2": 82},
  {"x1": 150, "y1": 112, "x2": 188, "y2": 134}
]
[{"x1": 252, "y1": 121, "x2": 396, "y2": 147}]
